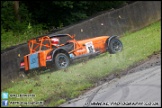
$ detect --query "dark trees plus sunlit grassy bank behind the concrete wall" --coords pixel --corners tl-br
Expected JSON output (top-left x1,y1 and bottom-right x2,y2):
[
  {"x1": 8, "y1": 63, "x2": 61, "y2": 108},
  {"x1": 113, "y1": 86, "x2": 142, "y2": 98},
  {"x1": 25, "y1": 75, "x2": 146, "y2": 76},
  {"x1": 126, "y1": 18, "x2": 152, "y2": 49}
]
[{"x1": 1, "y1": 1, "x2": 129, "y2": 50}]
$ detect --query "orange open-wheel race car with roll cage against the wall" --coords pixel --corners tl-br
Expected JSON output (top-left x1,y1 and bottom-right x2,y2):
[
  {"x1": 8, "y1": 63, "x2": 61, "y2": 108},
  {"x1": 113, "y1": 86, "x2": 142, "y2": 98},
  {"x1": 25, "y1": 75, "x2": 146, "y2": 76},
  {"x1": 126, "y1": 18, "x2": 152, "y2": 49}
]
[{"x1": 20, "y1": 34, "x2": 123, "y2": 71}]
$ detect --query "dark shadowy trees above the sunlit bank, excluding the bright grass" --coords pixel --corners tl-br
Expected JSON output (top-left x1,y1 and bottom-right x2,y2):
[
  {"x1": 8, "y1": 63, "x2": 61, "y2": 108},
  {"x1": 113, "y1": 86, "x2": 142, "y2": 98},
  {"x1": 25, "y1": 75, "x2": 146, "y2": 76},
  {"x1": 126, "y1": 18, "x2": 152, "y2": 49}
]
[{"x1": 1, "y1": 1, "x2": 126, "y2": 31}]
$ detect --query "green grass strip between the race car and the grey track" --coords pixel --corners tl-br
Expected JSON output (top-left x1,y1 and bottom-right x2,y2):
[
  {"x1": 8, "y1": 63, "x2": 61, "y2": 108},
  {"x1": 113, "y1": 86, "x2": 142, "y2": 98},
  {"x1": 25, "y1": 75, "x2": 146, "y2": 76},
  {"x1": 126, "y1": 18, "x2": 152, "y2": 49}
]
[{"x1": 3, "y1": 21, "x2": 161, "y2": 106}]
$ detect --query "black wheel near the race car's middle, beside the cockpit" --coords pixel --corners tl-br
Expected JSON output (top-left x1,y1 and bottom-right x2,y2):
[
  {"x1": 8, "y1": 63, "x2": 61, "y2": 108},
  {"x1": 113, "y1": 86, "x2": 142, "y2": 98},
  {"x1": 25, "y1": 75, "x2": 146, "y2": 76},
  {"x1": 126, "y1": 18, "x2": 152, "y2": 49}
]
[{"x1": 54, "y1": 53, "x2": 70, "y2": 69}]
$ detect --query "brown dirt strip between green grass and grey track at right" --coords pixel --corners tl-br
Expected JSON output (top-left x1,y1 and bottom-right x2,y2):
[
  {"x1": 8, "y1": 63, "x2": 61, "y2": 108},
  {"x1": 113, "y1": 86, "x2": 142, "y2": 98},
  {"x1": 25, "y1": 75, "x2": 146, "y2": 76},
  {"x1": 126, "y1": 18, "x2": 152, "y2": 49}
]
[{"x1": 95, "y1": 51, "x2": 161, "y2": 87}]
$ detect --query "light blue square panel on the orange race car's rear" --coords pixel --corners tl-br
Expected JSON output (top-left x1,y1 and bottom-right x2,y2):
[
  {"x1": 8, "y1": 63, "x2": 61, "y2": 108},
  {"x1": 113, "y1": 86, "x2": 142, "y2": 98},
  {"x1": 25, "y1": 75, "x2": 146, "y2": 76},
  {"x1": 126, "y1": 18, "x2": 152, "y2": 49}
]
[{"x1": 29, "y1": 53, "x2": 39, "y2": 69}]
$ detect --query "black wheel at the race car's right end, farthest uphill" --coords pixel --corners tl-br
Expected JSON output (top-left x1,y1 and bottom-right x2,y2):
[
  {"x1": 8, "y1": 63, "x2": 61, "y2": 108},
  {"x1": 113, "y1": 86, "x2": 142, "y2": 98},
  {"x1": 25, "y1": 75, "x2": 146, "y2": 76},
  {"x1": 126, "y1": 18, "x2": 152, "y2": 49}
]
[{"x1": 108, "y1": 38, "x2": 123, "y2": 54}]
